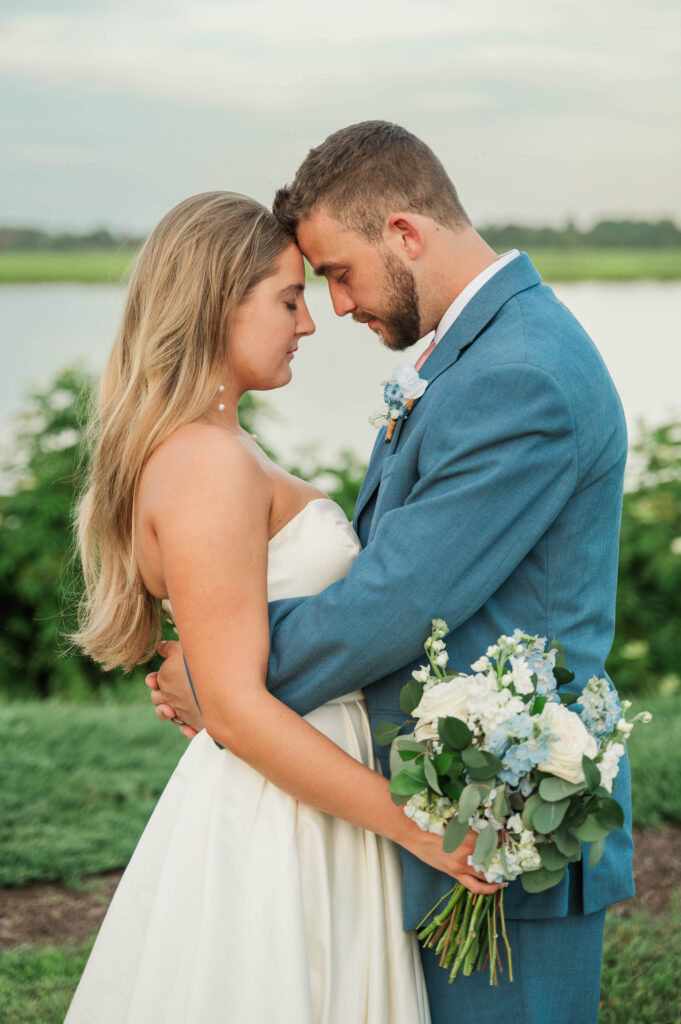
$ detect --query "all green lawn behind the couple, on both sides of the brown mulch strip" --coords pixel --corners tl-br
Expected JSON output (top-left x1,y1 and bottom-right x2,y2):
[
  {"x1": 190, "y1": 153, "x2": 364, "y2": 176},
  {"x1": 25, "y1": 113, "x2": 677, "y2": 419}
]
[{"x1": 0, "y1": 686, "x2": 681, "y2": 1024}]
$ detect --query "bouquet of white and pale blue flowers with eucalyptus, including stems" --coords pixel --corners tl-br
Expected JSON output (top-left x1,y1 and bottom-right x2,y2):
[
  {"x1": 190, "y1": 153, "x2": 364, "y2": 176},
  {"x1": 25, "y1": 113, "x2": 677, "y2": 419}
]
[{"x1": 376, "y1": 618, "x2": 651, "y2": 985}]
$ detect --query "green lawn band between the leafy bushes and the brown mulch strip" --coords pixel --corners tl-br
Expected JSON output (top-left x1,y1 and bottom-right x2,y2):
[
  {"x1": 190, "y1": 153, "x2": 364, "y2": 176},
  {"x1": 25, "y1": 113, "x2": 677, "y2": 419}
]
[{"x1": 0, "y1": 687, "x2": 681, "y2": 886}]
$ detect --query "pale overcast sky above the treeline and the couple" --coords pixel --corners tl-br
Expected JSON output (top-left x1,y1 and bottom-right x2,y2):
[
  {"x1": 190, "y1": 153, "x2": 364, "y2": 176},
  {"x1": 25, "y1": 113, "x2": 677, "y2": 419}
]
[{"x1": 0, "y1": 0, "x2": 681, "y2": 232}]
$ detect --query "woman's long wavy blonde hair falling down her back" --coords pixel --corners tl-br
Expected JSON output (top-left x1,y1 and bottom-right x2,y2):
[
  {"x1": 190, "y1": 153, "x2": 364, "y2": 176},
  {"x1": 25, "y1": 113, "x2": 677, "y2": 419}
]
[{"x1": 72, "y1": 191, "x2": 291, "y2": 670}]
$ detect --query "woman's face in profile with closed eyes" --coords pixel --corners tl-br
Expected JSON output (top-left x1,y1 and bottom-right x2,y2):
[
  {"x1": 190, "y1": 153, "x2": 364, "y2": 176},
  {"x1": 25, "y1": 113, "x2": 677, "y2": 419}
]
[{"x1": 227, "y1": 243, "x2": 314, "y2": 392}]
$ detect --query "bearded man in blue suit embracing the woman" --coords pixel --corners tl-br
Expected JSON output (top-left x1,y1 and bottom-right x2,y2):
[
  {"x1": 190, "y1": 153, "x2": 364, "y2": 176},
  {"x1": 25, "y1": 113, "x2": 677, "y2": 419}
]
[{"x1": 148, "y1": 121, "x2": 633, "y2": 1024}]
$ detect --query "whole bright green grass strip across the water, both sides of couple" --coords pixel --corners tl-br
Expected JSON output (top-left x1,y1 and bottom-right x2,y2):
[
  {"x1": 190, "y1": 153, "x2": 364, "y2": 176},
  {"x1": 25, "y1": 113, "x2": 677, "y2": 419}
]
[{"x1": 0, "y1": 249, "x2": 681, "y2": 284}]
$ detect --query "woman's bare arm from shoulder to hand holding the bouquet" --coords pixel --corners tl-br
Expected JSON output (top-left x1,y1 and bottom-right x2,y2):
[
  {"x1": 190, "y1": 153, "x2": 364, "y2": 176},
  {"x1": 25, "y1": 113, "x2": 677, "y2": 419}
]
[{"x1": 153, "y1": 434, "x2": 496, "y2": 892}]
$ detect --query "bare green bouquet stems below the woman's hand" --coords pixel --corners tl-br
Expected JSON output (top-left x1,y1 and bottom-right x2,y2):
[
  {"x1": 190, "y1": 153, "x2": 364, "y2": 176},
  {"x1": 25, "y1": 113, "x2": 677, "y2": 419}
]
[{"x1": 417, "y1": 882, "x2": 513, "y2": 985}]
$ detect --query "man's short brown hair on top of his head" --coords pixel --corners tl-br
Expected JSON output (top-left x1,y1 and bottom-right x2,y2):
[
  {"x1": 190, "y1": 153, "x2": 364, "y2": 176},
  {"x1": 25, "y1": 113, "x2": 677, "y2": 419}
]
[{"x1": 272, "y1": 121, "x2": 470, "y2": 242}]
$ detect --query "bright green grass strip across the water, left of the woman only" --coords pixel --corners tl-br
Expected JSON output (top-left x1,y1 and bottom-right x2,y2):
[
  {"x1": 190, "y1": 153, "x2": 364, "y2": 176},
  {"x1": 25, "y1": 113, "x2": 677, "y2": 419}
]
[{"x1": 0, "y1": 249, "x2": 135, "y2": 285}]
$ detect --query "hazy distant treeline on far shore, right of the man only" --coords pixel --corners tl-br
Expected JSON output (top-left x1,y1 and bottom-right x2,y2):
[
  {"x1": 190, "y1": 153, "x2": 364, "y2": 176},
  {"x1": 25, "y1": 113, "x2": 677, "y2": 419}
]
[{"x1": 479, "y1": 220, "x2": 681, "y2": 250}]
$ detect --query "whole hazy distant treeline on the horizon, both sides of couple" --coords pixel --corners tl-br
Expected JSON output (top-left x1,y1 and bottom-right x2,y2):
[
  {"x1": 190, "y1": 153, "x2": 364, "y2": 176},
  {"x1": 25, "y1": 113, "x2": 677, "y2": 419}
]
[{"x1": 0, "y1": 220, "x2": 681, "y2": 252}]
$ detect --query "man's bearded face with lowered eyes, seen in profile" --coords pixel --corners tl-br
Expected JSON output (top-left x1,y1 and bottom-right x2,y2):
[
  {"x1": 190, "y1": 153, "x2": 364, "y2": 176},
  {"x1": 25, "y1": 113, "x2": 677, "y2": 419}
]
[{"x1": 297, "y1": 210, "x2": 421, "y2": 351}]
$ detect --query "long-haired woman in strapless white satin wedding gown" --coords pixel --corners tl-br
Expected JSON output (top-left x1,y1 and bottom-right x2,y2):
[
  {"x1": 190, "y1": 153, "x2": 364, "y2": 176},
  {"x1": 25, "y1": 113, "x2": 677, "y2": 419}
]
[{"x1": 67, "y1": 191, "x2": 488, "y2": 1024}]
